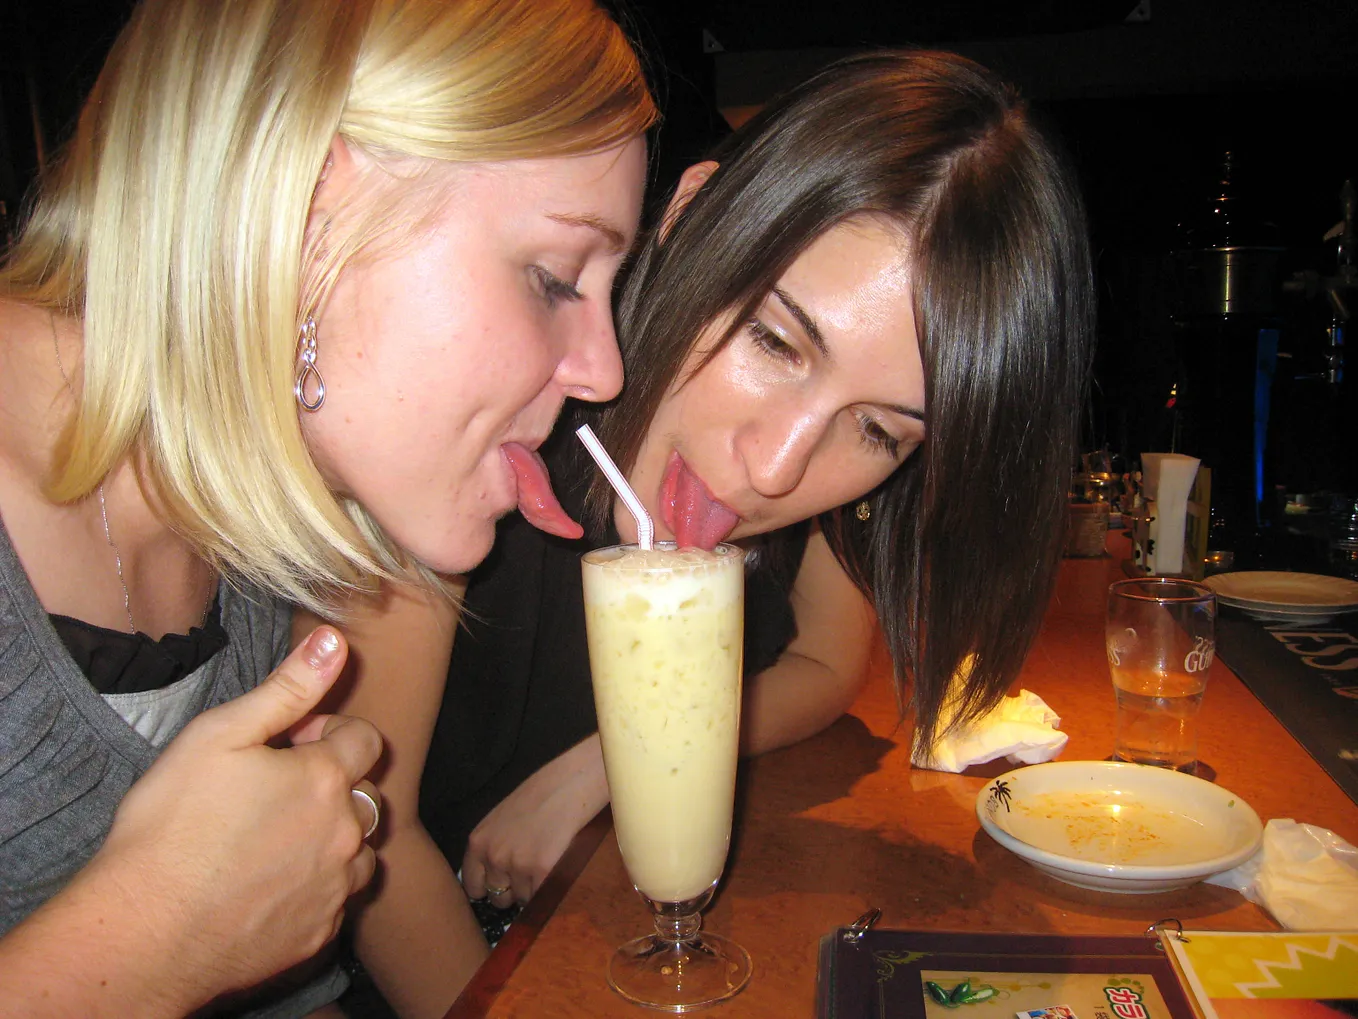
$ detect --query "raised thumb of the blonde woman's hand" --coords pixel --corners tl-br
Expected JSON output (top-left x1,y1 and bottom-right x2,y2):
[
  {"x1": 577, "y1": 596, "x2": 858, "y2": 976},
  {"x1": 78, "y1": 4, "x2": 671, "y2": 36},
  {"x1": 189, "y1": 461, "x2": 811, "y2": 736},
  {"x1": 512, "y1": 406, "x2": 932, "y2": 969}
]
[{"x1": 200, "y1": 626, "x2": 349, "y2": 747}]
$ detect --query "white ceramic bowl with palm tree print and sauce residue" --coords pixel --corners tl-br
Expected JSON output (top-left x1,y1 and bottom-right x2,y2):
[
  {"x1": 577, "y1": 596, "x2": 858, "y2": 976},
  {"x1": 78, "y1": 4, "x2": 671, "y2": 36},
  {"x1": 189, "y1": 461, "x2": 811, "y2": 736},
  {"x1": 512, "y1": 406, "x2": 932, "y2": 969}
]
[{"x1": 976, "y1": 761, "x2": 1263, "y2": 893}]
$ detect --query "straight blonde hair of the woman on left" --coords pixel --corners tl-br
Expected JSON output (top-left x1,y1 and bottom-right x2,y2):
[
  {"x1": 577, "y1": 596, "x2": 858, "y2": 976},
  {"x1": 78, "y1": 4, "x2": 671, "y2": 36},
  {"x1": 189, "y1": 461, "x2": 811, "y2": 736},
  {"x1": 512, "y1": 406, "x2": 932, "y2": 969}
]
[{"x1": 0, "y1": 0, "x2": 656, "y2": 611}]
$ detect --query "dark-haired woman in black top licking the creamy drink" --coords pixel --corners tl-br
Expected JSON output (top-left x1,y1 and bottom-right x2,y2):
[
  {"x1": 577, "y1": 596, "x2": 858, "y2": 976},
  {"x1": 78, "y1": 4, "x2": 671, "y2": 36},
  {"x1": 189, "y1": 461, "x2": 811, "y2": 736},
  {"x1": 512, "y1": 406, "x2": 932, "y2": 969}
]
[{"x1": 317, "y1": 52, "x2": 1093, "y2": 1019}]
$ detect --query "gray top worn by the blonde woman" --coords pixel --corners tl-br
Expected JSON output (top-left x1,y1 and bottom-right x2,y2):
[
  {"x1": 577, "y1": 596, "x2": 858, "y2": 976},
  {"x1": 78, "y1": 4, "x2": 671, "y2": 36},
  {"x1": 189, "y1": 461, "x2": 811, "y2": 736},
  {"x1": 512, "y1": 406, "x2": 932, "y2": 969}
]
[{"x1": 0, "y1": 519, "x2": 348, "y2": 1019}]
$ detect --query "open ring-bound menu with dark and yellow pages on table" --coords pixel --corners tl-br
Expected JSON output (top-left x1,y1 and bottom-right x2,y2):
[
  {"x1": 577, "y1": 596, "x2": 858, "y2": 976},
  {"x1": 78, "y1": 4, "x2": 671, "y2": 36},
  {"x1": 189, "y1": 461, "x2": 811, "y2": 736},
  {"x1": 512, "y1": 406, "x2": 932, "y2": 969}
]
[{"x1": 816, "y1": 928, "x2": 1358, "y2": 1019}]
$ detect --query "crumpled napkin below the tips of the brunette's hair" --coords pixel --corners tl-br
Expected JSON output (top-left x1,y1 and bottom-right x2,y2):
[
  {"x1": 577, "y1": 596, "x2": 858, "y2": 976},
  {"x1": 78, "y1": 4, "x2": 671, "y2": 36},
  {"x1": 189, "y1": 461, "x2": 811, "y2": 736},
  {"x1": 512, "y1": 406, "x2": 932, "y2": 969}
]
[{"x1": 910, "y1": 687, "x2": 1070, "y2": 772}]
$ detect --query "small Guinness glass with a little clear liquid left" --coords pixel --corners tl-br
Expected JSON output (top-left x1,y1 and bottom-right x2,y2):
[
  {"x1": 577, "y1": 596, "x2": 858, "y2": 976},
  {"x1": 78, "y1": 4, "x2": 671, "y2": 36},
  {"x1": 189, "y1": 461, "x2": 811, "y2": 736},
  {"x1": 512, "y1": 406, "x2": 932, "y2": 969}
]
[{"x1": 1104, "y1": 577, "x2": 1217, "y2": 774}]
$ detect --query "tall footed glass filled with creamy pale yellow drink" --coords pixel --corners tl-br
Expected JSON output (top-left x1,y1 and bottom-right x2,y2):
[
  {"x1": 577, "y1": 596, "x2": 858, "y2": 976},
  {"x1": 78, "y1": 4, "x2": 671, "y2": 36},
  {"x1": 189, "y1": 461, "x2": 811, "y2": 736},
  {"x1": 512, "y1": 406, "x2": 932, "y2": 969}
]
[{"x1": 583, "y1": 542, "x2": 750, "y2": 1012}]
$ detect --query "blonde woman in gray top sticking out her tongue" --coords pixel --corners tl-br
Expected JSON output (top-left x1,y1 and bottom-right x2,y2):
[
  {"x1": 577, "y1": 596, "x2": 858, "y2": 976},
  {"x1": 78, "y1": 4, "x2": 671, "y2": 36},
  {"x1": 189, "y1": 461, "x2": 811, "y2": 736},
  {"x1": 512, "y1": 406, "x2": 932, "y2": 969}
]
[{"x1": 0, "y1": 0, "x2": 655, "y2": 1016}]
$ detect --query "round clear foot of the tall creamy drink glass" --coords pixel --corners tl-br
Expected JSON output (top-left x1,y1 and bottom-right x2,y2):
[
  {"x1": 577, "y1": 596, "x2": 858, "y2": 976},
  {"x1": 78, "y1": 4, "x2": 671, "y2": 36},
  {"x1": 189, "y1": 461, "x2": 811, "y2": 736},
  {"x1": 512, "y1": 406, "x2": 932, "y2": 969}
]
[{"x1": 608, "y1": 931, "x2": 751, "y2": 1012}]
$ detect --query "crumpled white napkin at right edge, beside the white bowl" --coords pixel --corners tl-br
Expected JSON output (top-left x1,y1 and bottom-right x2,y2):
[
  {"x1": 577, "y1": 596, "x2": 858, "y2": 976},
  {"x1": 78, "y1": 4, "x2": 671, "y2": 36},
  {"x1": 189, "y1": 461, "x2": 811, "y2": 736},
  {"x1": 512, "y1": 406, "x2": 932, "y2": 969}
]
[{"x1": 1207, "y1": 818, "x2": 1358, "y2": 931}]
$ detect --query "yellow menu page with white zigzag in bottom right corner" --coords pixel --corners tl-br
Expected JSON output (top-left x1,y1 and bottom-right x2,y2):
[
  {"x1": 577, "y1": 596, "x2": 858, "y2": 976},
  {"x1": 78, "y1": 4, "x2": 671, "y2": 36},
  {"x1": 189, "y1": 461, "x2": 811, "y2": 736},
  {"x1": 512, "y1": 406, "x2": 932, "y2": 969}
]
[{"x1": 1161, "y1": 929, "x2": 1358, "y2": 1019}]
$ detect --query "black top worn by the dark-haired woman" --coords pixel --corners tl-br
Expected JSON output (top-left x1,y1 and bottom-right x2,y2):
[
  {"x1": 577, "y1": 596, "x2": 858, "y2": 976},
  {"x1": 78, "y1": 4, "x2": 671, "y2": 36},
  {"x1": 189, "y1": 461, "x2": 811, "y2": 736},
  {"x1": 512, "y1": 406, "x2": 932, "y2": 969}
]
[{"x1": 420, "y1": 470, "x2": 808, "y2": 867}]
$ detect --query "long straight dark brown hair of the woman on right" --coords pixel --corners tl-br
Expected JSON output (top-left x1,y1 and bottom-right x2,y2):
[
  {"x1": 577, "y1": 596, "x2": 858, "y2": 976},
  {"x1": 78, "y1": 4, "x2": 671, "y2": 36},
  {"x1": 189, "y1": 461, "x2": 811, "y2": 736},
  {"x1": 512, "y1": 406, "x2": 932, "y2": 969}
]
[{"x1": 588, "y1": 52, "x2": 1093, "y2": 740}]
